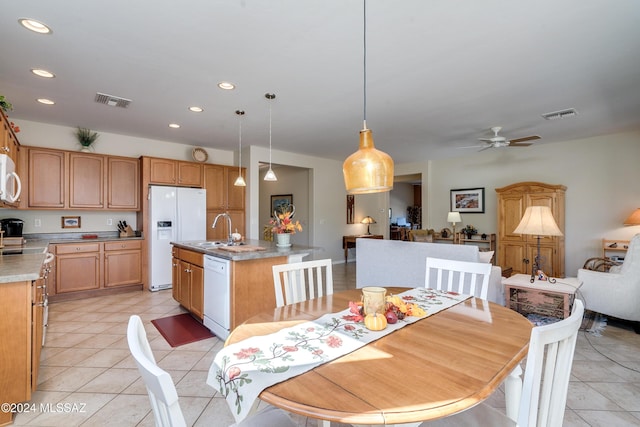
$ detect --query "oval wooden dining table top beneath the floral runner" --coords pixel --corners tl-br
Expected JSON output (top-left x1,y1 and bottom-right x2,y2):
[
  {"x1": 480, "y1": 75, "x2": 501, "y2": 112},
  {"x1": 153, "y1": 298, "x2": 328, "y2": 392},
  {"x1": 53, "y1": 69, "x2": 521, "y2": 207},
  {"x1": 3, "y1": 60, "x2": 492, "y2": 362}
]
[{"x1": 226, "y1": 288, "x2": 532, "y2": 425}]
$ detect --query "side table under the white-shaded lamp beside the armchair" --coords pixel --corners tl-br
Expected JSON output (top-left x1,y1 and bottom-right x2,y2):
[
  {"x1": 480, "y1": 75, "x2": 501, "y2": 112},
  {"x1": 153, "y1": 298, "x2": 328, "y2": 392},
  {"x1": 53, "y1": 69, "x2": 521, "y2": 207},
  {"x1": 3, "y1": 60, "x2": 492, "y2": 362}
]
[{"x1": 502, "y1": 274, "x2": 582, "y2": 319}]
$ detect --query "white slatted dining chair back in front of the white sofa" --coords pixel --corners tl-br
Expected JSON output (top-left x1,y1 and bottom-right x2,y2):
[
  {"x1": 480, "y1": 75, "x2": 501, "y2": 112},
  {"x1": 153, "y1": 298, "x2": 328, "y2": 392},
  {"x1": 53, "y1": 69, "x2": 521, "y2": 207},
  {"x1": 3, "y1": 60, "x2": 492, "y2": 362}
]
[{"x1": 424, "y1": 257, "x2": 491, "y2": 299}]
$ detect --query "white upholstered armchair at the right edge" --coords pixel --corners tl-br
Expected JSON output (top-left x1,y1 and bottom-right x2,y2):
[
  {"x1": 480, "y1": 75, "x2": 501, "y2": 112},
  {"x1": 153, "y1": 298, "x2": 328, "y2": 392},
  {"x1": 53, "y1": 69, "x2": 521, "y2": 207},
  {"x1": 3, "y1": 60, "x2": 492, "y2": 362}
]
[{"x1": 578, "y1": 234, "x2": 640, "y2": 333}]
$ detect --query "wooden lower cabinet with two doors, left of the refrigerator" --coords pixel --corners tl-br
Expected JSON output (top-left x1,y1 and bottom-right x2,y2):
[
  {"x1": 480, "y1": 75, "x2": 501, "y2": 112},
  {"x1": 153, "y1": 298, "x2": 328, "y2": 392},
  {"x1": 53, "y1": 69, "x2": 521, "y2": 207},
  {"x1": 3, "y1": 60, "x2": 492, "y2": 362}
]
[{"x1": 50, "y1": 240, "x2": 142, "y2": 301}]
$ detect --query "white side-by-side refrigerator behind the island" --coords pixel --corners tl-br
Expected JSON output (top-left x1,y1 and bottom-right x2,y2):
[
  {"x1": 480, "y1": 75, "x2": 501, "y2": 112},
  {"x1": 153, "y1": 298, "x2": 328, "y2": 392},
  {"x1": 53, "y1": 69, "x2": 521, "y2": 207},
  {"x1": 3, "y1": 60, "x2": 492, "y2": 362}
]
[{"x1": 149, "y1": 185, "x2": 207, "y2": 291}]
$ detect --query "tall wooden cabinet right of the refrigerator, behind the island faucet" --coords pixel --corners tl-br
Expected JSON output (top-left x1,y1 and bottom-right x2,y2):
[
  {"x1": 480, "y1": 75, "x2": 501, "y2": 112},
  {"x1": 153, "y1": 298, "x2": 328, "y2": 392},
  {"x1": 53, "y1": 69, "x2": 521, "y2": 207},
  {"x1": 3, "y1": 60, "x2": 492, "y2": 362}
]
[{"x1": 204, "y1": 165, "x2": 246, "y2": 240}]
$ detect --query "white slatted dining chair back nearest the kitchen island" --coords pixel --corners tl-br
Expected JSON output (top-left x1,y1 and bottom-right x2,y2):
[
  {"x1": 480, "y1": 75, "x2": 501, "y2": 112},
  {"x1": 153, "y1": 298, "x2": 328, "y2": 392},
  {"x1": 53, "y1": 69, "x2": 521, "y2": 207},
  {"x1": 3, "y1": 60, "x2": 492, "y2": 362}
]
[{"x1": 272, "y1": 259, "x2": 333, "y2": 307}]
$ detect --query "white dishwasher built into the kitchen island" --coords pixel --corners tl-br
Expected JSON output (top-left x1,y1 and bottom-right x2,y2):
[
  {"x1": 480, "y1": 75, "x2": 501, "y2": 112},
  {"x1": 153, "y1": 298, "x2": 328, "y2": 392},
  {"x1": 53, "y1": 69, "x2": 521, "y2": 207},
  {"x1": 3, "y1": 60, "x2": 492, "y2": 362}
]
[{"x1": 204, "y1": 255, "x2": 231, "y2": 340}]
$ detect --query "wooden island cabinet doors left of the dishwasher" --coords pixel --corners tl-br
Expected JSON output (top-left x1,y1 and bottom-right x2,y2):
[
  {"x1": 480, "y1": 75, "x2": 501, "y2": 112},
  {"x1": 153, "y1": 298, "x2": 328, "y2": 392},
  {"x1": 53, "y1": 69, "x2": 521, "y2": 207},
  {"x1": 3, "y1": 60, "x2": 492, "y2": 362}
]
[{"x1": 171, "y1": 247, "x2": 204, "y2": 320}]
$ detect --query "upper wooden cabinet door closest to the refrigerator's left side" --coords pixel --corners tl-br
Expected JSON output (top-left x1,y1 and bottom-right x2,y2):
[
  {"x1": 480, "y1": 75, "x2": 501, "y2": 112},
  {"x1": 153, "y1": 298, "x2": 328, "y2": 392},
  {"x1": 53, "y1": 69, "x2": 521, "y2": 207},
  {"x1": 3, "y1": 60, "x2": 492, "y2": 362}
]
[{"x1": 107, "y1": 157, "x2": 140, "y2": 210}]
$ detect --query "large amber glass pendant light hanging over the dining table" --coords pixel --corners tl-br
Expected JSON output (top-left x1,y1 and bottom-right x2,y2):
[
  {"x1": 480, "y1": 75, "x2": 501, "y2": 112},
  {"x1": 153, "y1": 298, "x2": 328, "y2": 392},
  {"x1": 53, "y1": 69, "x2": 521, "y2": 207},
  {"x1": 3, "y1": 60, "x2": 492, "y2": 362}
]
[{"x1": 342, "y1": 0, "x2": 393, "y2": 194}]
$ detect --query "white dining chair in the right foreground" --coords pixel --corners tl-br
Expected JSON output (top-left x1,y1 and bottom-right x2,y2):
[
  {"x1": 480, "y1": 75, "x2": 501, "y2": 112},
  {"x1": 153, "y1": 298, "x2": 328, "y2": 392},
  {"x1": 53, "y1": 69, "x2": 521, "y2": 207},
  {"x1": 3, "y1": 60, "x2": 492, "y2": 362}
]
[{"x1": 420, "y1": 299, "x2": 584, "y2": 427}]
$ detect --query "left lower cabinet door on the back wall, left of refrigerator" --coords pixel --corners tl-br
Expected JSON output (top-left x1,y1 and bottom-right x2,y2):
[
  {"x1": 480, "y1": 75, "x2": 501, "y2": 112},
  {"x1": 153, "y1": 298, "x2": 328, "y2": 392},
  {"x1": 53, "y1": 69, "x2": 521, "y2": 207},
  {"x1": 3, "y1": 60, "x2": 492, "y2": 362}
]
[{"x1": 56, "y1": 252, "x2": 100, "y2": 294}]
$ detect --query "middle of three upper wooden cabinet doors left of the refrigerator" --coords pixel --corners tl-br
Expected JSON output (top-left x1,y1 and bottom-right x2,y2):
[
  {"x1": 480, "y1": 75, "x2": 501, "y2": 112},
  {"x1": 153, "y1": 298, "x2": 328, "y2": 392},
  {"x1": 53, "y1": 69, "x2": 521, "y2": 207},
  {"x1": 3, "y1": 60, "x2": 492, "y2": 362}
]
[{"x1": 69, "y1": 153, "x2": 104, "y2": 209}]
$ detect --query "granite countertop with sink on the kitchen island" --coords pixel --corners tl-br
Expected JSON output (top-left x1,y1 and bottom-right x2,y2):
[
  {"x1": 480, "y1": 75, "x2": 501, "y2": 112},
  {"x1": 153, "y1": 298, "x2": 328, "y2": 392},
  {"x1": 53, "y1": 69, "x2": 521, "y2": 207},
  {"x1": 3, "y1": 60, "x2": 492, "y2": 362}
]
[{"x1": 171, "y1": 240, "x2": 319, "y2": 261}]
